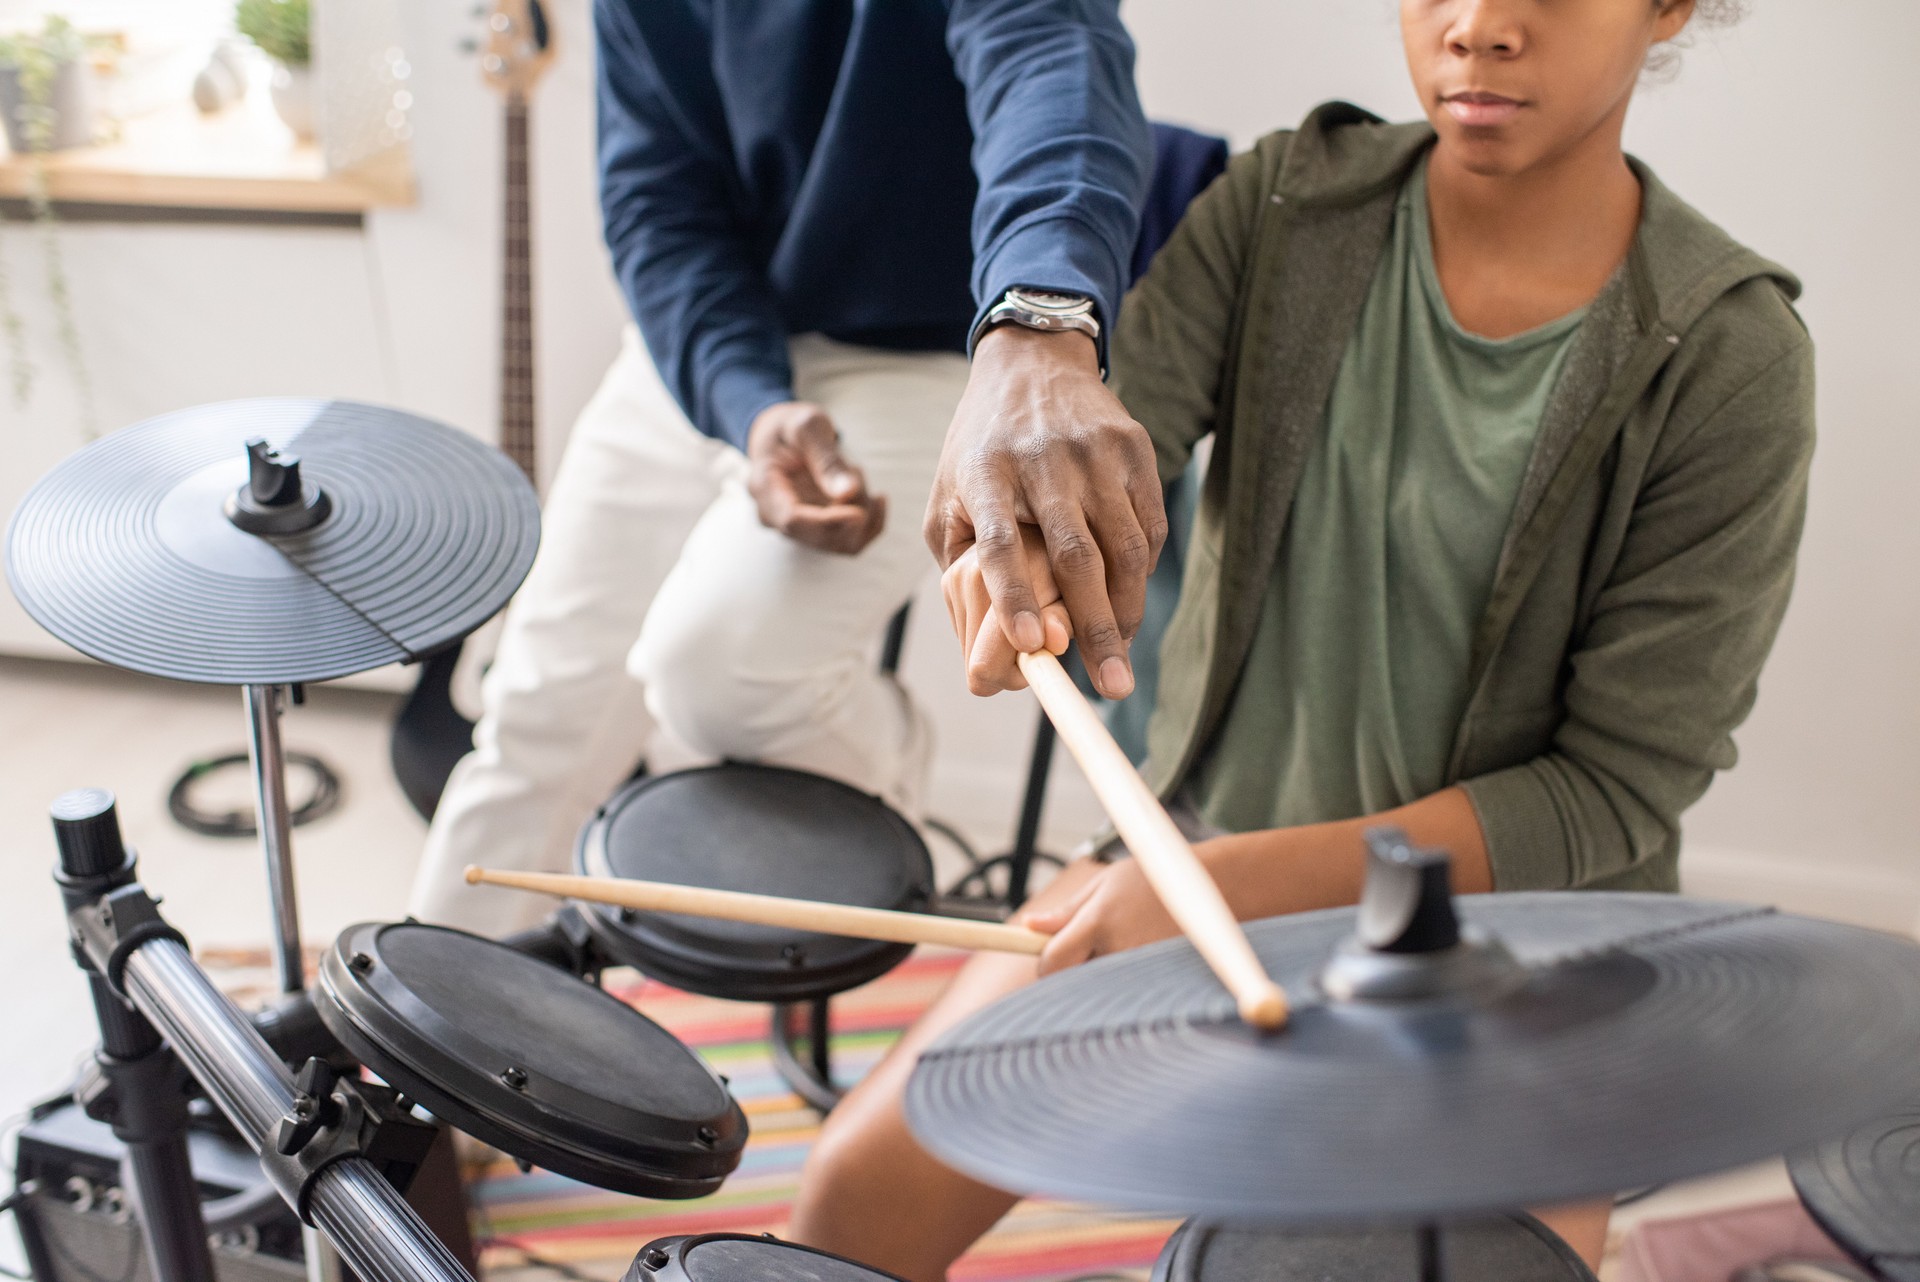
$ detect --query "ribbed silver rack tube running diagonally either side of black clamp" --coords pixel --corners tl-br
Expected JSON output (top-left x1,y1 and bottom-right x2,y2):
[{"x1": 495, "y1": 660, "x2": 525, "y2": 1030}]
[{"x1": 127, "y1": 936, "x2": 472, "y2": 1282}]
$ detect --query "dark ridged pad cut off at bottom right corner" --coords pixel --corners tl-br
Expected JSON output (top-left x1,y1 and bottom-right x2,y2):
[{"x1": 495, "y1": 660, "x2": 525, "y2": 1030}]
[{"x1": 1788, "y1": 1096, "x2": 1920, "y2": 1282}]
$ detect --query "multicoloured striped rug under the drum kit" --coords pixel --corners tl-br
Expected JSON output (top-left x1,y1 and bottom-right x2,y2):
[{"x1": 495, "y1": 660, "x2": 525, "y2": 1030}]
[{"x1": 470, "y1": 950, "x2": 1173, "y2": 1282}]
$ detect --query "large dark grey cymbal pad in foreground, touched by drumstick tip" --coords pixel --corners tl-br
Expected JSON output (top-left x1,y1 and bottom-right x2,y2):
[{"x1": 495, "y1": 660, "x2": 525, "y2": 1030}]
[{"x1": 906, "y1": 892, "x2": 1920, "y2": 1224}]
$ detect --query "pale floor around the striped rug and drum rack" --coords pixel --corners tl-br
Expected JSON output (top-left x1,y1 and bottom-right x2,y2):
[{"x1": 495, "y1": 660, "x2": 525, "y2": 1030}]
[{"x1": 0, "y1": 658, "x2": 1843, "y2": 1267}]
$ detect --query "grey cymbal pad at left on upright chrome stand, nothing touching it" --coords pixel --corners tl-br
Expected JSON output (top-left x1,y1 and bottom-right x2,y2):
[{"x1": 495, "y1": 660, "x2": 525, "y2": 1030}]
[{"x1": 8, "y1": 397, "x2": 540, "y2": 685}]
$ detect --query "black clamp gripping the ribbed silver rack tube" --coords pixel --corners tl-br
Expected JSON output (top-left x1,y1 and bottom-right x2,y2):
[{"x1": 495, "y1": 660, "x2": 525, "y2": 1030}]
[{"x1": 259, "y1": 1059, "x2": 440, "y2": 1224}]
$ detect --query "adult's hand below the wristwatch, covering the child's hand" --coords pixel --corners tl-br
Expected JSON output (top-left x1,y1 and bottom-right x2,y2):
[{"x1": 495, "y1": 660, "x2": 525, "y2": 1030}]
[{"x1": 925, "y1": 324, "x2": 1167, "y2": 699}]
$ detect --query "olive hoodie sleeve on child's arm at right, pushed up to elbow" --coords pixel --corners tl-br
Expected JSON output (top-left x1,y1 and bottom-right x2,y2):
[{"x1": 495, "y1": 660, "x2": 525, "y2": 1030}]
[{"x1": 1463, "y1": 338, "x2": 1814, "y2": 890}]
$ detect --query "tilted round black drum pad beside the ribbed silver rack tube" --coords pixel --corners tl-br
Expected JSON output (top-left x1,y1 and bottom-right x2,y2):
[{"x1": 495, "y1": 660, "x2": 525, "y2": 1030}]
[{"x1": 315, "y1": 921, "x2": 747, "y2": 1198}]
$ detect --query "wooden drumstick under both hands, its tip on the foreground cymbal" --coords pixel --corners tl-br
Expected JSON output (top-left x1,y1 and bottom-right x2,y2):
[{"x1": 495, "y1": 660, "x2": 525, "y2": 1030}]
[{"x1": 1020, "y1": 651, "x2": 1286, "y2": 1031}]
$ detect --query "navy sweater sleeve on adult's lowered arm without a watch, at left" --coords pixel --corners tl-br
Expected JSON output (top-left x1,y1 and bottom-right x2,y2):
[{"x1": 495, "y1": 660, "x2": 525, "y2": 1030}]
[{"x1": 593, "y1": 0, "x2": 793, "y2": 449}]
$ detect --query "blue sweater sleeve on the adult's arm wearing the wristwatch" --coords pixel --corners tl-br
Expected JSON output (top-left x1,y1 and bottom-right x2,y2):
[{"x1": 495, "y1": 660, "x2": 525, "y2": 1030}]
[{"x1": 947, "y1": 0, "x2": 1154, "y2": 365}]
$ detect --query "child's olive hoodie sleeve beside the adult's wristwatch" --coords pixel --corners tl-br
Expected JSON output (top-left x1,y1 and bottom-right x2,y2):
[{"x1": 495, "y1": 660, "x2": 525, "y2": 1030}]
[{"x1": 1114, "y1": 134, "x2": 1284, "y2": 482}]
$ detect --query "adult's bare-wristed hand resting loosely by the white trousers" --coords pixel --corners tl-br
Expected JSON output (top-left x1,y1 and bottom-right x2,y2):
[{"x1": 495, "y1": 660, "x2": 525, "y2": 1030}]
[{"x1": 747, "y1": 401, "x2": 887, "y2": 557}]
